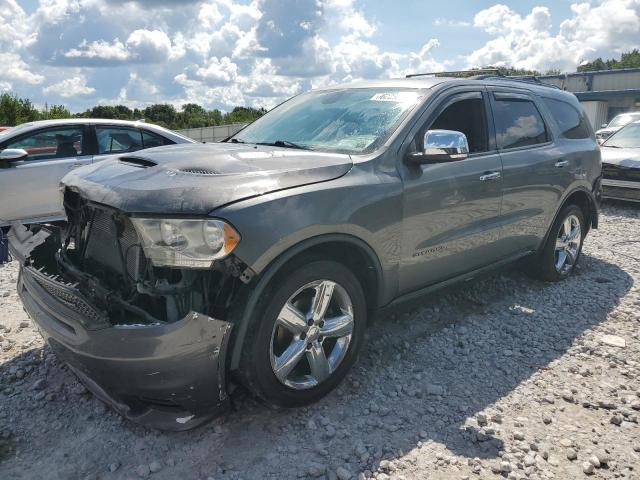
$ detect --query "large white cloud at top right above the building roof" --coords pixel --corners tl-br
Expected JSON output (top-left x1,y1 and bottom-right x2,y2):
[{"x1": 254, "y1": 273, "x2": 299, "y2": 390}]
[{"x1": 467, "y1": 0, "x2": 640, "y2": 71}]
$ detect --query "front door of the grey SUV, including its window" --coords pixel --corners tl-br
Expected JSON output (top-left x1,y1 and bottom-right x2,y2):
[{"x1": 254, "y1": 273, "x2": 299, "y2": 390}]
[{"x1": 400, "y1": 88, "x2": 502, "y2": 293}]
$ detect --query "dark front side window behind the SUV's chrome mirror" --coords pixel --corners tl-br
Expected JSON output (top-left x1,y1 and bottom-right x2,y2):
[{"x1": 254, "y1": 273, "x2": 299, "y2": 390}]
[{"x1": 429, "y1": 96, "x2": 489, "y2": 153}]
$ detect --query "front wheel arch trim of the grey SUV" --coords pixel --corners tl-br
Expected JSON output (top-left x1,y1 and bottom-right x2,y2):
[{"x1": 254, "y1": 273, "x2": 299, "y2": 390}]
[{"x1": 229, "y1": 234, "x2": 384, "y2": 370}]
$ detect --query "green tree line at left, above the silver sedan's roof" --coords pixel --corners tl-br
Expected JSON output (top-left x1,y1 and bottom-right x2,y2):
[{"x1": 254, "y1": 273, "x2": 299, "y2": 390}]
[{"x1": 0, "y1": 97, "x2": 267, "y2": 130}]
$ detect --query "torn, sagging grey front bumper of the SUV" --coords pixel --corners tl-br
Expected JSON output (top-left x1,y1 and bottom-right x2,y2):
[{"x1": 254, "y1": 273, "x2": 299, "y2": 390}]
[{"x1": 12, "y1": 225, "x2": 231, "y2": 430}]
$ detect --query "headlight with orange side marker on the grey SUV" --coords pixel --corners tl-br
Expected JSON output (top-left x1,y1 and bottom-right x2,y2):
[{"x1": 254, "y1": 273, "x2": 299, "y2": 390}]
[{"x1": 131, "y1": 218, "x2": 240, "y2": 268}]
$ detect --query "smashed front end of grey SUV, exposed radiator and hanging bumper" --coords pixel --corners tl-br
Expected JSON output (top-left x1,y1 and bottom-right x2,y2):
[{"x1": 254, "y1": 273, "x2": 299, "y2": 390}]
[{"x1": 10, "y1": 190, "x2": 242, "y2": 430}]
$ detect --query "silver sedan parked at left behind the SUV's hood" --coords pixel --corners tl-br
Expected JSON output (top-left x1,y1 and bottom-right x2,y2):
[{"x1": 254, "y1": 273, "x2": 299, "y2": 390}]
[{"x1": 0, "y1": 118, "x2": 195, "y2": 227}]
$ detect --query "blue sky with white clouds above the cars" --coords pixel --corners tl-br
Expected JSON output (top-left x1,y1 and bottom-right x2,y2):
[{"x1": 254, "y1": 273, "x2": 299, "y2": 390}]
[{"x1": 0, "y1": 0, "x2": 640, "y2": 112}]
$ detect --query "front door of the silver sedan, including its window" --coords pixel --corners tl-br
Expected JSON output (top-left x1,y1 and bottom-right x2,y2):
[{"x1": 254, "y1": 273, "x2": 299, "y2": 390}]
[{"x1": 0, "y1": 125, "x2": 92, "y2": 222}]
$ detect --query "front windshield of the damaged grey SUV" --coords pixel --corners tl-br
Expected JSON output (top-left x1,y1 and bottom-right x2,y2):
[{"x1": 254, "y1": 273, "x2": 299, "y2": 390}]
[{"x1": 230, "y1": 88, "x2": 424, "y2": 154}]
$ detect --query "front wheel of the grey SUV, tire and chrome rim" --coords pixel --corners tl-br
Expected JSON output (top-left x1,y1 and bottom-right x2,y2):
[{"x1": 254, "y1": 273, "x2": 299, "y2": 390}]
[{"x1": 239, "y1": 260, "x2": 367, "y2": 407}]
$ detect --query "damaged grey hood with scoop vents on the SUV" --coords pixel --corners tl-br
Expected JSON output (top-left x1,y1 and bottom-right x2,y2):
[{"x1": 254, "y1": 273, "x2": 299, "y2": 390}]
[{"x1": 62, "y1": 143, "x2": 352, "y2": 215}]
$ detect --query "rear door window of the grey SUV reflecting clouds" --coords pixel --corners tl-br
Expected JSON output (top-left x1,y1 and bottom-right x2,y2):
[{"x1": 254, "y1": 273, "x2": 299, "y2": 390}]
[{"x1": 493, "y1": 98, "x2": 549, "y2": 149}]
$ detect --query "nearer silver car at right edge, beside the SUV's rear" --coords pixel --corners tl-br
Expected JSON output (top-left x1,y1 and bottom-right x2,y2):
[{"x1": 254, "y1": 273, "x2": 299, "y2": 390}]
[{"x1": 600, "y1": 121, "x2": 640, "y2": 202}]
